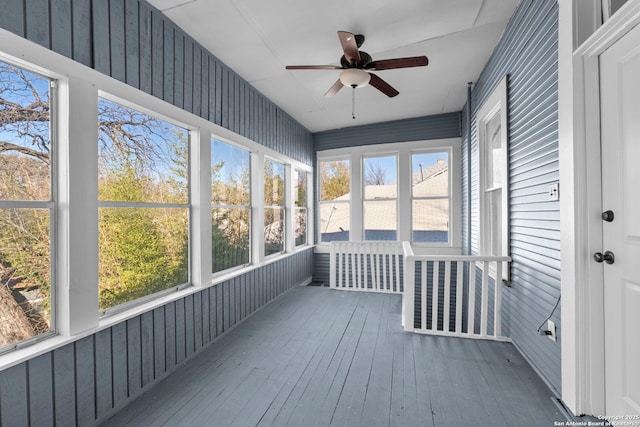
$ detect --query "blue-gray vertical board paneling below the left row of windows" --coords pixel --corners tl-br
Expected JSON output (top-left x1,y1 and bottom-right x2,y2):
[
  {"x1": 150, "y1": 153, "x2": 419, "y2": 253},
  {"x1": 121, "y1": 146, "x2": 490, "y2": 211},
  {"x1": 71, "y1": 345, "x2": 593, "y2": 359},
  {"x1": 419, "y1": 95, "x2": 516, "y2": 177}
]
[{"x1": 0, "y1": 249, "x2": 313, "y2": 426}]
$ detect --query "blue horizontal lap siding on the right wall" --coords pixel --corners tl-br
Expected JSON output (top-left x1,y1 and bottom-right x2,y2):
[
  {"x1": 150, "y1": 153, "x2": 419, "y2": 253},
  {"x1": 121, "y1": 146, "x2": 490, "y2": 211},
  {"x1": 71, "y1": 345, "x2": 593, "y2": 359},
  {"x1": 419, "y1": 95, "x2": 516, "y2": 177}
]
[{"x1": 462, "y1": 0, "x2": 561, "y2": 394}]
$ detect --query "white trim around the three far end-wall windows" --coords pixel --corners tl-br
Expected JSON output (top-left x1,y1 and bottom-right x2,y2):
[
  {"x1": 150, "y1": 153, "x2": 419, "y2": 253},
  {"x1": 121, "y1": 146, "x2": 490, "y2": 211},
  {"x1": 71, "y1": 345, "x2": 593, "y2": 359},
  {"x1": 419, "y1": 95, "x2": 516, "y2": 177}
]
[{"x1": 315, "y1": 138, "x2": 462, "y2": 255}]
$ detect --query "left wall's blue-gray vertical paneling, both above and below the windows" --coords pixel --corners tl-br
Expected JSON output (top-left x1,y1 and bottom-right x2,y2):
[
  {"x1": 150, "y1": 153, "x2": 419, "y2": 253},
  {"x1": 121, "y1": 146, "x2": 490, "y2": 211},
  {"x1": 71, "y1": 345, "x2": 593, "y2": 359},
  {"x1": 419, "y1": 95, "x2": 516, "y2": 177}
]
[{"x1": 0, "y1": 0, "x2": 313, "y2": 426}]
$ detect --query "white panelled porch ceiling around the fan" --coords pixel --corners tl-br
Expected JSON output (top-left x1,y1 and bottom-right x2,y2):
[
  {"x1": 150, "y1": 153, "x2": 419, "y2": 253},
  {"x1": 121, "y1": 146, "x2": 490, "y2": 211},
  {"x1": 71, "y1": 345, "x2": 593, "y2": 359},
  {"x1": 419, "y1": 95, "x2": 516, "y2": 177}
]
[{"x1": 149, "y1": 0, "x2": 519, "y2": 132}]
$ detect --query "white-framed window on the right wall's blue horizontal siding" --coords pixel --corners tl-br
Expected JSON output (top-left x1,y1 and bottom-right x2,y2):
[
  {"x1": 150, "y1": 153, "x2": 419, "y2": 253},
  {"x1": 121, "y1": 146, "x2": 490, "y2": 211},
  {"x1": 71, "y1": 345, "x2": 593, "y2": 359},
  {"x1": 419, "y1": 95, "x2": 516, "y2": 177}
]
[{"x1": 477, "y1": 77, "x2": 509, "y2": 279}]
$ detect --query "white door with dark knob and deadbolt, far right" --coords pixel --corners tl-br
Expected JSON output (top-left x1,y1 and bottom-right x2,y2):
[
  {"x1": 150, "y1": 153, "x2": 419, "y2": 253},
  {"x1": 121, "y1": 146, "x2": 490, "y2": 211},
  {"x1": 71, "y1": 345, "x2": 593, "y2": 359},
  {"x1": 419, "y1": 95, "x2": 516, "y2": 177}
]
[{"x1": 600, "y1": 21, "x2": 640, "y2": 416}]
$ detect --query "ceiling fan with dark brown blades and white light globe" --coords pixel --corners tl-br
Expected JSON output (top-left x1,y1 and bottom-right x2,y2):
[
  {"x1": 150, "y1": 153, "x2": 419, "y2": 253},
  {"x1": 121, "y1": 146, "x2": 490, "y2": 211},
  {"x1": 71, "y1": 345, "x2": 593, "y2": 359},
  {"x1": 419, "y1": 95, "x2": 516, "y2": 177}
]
[{"x1": 285, "y1": 31, "x2": 429, "y2": 98}]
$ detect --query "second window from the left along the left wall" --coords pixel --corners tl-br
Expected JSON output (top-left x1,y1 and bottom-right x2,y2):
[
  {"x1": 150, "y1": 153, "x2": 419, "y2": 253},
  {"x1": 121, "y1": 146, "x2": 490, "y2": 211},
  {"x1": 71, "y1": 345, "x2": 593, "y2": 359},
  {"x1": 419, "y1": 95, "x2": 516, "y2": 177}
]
[{"x1": 98, "y1": 98, "x2": 189, "y2": 310}]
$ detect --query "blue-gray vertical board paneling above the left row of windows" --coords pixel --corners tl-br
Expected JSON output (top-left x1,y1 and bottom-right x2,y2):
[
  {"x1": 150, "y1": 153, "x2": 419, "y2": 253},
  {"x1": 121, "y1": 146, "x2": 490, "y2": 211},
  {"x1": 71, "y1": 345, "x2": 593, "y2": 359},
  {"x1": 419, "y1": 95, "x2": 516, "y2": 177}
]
[{"x1": 0, "y1": 0, "x2": 313, "y2": 165}]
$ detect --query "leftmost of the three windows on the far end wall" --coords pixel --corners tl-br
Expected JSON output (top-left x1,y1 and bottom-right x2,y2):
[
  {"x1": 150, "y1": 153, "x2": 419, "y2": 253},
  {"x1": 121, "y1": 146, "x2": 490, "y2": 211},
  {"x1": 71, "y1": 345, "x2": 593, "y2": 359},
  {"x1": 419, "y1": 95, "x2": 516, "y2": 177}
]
[{"x1": 318, "y1": 160, "x2": 351, "y2": 242}]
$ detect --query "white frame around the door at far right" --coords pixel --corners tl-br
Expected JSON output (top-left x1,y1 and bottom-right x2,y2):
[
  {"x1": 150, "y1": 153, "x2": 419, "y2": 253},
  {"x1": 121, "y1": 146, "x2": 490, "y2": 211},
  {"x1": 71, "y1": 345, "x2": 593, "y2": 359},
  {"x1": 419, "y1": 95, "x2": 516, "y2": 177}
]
[{"x1": 558, "y1": 0, "x2": 640, "y2": 415}]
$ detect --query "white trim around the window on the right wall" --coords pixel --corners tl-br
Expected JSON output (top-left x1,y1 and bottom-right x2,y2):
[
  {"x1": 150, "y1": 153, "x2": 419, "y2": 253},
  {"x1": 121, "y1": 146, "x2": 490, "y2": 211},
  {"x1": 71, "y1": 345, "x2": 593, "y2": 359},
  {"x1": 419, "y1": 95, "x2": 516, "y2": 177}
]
[{"x1": 476, "y1": 76, "x2": 509, "y2": 281}]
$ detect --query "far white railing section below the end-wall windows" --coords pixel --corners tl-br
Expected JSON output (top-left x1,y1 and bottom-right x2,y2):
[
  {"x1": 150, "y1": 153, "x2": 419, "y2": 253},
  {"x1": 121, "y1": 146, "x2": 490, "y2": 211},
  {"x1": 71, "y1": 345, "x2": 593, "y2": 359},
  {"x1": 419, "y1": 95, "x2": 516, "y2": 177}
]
[{"x1": 329, "y1": 241, "x2": 403, "y2": 293}]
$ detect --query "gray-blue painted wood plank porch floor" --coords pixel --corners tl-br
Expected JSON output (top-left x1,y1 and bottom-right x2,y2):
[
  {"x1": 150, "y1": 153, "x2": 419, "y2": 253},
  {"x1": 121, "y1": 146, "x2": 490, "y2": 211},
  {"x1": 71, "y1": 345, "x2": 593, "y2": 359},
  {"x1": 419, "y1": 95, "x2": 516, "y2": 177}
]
[{"x1": 106, "y1": 286, "x2": 566, "y2": 427}]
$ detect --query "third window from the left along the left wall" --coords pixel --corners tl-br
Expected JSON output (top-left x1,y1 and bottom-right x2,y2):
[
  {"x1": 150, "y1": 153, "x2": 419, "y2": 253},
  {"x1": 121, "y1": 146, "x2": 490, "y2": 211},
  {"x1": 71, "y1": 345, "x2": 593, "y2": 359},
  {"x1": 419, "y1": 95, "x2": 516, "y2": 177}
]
[{"x1": 211, "y1": 139, "x2": 251, "y2": 273}]
